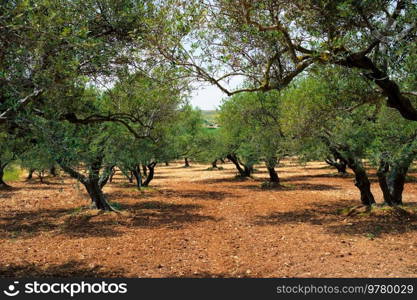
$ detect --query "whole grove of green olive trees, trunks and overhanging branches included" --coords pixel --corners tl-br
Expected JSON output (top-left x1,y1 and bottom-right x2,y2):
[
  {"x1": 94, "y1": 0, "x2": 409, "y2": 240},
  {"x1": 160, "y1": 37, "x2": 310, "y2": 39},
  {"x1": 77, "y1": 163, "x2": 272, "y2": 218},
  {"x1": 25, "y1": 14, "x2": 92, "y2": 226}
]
[{"x1": 0, "y1": 0, "x2": 417, "y2": 210}]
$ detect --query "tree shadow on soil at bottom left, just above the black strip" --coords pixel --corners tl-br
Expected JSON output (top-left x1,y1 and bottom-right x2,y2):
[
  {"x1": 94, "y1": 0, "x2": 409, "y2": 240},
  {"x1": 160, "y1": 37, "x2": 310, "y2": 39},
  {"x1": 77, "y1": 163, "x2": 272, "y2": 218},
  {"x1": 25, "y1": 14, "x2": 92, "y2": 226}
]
[{"x1": 0, "y1": 260, "x2": 126, "y2": 278}]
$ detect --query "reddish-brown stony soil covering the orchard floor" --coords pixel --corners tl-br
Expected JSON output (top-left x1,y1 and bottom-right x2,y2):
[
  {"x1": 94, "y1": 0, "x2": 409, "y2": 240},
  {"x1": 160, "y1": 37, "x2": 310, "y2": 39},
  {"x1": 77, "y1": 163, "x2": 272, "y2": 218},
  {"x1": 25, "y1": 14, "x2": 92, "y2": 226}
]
[{"x1": 0, "y1": 161, "x2": 417, "y2": 277}]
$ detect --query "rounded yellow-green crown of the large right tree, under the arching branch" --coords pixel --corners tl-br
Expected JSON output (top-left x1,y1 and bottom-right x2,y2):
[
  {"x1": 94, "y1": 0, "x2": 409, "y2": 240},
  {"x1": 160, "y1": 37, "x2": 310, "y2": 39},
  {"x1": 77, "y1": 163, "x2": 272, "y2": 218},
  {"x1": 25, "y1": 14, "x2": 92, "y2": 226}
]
[{"x1": 282, "y1": 68, "x2": 382, "y2": 160}]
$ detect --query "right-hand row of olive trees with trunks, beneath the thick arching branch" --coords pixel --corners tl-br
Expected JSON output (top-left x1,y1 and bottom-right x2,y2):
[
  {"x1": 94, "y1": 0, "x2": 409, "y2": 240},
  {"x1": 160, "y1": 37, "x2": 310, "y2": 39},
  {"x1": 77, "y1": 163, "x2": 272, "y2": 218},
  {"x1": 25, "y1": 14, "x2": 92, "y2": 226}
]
[{"x1": 205, "y1": 67, "x2": 417, "y2": 205}]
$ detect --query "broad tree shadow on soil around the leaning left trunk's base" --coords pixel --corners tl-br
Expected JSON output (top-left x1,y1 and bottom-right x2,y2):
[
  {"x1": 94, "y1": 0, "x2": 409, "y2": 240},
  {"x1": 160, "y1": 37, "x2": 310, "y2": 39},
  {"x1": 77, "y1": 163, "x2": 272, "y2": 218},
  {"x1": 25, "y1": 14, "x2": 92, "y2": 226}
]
[{"x1": 0, "y1": 201, "x2": 219, "y2": 239}]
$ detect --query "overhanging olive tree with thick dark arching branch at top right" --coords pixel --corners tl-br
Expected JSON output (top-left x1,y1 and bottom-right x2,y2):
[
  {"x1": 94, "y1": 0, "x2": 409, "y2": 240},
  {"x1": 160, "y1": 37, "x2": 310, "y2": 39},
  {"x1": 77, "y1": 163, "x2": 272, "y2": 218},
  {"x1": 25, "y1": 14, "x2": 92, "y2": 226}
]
[{"x1": 154, "y1": 0, "x2": 417, "y2": 121}]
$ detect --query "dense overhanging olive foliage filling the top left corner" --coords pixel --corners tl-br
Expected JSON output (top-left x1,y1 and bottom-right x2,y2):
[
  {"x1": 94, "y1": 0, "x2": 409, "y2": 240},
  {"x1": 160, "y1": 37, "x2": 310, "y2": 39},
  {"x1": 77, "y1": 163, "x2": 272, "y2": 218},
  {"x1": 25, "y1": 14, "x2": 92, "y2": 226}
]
[{"x1": 0, "y1": 0, "x2": 159, "y2": 119}]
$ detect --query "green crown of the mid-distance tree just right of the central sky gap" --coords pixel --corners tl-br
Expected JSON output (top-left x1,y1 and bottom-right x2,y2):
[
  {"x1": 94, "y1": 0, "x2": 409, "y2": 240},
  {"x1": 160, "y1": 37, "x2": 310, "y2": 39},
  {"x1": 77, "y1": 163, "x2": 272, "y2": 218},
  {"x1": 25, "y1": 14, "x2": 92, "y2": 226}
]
[{"x1": 217, "y1": 92, "x2": 289, "y2": 166}]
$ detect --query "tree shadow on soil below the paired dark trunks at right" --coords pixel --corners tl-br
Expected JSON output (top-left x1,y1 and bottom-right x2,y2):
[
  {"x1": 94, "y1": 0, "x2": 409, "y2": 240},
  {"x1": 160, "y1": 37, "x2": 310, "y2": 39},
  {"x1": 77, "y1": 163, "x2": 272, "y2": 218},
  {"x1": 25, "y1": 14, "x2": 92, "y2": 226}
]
[{"x1": 253, "y1": 200, "x2": 417, "y2": 238}]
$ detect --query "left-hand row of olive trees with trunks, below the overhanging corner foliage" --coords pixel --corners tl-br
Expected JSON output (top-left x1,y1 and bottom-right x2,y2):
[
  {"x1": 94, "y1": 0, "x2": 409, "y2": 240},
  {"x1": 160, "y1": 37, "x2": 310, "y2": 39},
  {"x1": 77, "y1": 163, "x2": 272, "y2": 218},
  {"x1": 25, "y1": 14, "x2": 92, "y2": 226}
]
[{"x1": 0, "y1": 67, "x2": 210, "y2": 210}]
